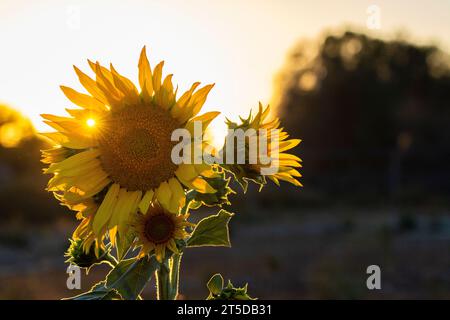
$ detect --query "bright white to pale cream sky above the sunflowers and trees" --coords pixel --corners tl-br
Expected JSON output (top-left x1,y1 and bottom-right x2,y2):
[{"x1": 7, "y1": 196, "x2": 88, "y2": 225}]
[{"x1": 0, "y1": 0, "x2": 450, "y2": 141}]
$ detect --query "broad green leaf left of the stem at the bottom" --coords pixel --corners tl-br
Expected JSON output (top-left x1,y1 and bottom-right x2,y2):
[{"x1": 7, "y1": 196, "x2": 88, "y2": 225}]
[{"x1": 106, "y1": 256, "x2": 160, "y2": 300}]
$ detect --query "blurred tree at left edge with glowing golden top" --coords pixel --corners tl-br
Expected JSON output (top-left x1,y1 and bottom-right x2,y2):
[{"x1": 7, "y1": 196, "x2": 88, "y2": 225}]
[{"x1": 0, "y1": 105, "x2": 65, "y2": 225}]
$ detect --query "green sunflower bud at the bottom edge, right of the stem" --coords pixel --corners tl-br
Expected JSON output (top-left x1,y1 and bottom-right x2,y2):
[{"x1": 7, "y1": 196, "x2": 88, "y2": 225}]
[{"x1": 206, "y1": 273, "x2": 256, "y2": 300}]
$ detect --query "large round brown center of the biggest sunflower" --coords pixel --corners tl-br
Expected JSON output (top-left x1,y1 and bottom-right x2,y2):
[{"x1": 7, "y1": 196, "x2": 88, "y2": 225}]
[{"x1": 98, "y1": 105, "x2": 179, "y2": 191}]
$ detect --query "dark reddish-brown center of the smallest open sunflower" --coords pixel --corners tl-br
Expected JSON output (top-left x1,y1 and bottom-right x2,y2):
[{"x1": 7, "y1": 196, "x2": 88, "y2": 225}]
[{"x1": 144, "y1": 213, "x2": 175, "y2": 244}]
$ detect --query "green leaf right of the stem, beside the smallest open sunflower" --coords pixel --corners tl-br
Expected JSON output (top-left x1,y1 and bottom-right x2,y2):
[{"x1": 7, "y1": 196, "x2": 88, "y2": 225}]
[{"x1": 187, "y1": 210, "x2": 233, "y2": 247}]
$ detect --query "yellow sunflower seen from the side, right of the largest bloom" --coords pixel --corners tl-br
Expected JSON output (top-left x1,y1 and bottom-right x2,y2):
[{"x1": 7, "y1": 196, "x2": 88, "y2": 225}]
[{"x1": 222, "y1": 103, "x2": 302, "y2": 190}]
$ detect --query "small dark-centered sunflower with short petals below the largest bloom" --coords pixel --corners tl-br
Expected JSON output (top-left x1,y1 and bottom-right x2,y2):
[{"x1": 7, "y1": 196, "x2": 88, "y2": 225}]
[{"x1": 131, "y1": 202, "x2": 194, "y2": 262}]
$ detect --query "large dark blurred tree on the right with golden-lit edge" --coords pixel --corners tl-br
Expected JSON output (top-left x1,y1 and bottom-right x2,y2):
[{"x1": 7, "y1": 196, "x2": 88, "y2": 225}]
[{"x1": 277, "y1": 32, "x2": 450, "y2": 201}]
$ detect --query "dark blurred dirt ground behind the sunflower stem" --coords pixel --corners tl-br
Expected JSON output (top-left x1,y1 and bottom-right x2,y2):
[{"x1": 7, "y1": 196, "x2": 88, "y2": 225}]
[{"x1": 0, "y1": 210, "x2": 450, "y2": 299}]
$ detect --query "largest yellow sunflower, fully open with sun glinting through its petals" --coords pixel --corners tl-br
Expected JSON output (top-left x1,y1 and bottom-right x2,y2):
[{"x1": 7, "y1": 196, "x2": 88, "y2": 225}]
[{"x1": 42, "y1": 47, "x2": 219, "y2": 248}]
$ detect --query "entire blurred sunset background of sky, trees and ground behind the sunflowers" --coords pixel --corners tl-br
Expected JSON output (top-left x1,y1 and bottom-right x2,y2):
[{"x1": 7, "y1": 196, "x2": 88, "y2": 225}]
[{"x1": 0, "y1": 0, "x2": 450, "y2": 299}]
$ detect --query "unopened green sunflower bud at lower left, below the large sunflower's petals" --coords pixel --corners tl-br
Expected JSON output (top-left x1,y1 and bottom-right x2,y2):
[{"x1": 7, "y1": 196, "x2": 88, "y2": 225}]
[{"x1": 64, "y1": 239, "x2": 110, "y2": 271}]
